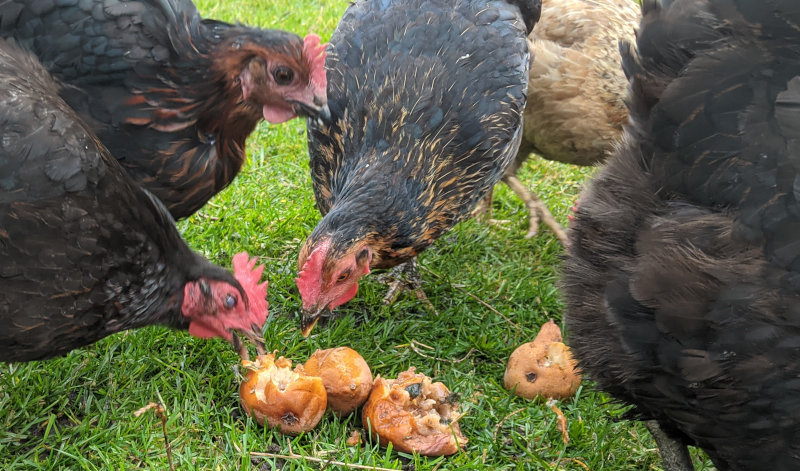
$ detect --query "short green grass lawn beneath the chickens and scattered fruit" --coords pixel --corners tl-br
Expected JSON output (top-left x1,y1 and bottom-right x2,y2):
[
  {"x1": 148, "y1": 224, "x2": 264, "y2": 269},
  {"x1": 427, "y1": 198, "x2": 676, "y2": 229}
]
[{"x1": 0, "y1": 0, "x2": 710, "y2": 471}]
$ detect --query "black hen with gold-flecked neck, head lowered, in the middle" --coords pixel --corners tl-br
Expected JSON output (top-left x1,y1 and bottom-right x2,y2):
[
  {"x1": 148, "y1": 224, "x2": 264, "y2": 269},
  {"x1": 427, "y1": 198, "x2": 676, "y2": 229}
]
[{"x1": 297, "y1": 0, "x2": 540, "y2": 335}]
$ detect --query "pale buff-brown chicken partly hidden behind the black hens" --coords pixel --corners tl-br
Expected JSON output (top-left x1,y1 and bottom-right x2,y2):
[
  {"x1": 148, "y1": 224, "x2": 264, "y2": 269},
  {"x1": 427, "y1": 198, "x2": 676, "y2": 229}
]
[{"x1": 477, "y1": 0, "x2": 640, "y2": 243}]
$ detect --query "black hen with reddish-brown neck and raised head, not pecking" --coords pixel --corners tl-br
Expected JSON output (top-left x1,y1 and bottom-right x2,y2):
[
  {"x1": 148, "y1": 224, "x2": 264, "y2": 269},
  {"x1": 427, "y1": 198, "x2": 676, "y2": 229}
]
[{"x1": 0, "y1": 0, "x2": 327, "y2": 219}]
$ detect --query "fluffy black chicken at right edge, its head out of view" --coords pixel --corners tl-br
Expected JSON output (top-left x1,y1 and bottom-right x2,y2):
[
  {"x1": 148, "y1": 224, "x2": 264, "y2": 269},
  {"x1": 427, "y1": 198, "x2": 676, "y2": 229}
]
[{"x1": 562, "y1": 0, "x2": 800, "y2": 471}]
